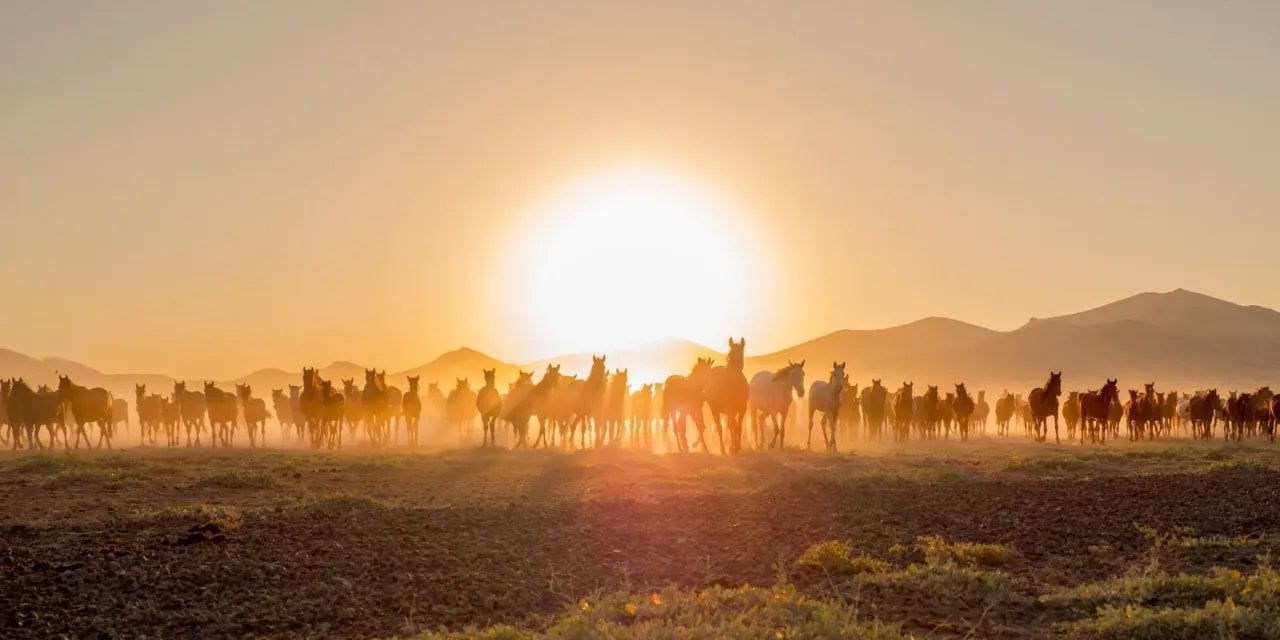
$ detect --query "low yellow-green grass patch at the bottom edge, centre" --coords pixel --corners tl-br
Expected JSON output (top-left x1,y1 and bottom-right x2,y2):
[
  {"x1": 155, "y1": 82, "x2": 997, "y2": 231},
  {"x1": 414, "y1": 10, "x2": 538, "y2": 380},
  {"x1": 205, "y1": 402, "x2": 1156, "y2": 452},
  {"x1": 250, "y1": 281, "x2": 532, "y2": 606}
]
[{"x1": 421, "y1": 585, "x2": 910, "y2": 640}]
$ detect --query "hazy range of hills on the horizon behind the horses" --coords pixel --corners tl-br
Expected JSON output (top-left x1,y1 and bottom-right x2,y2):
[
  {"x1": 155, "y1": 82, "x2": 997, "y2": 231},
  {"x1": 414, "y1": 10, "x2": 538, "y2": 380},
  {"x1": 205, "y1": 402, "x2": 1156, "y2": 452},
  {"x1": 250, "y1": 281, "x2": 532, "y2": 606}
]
[{"x1": 0, "y1": 289, "x2": 1280, "y2": 399}]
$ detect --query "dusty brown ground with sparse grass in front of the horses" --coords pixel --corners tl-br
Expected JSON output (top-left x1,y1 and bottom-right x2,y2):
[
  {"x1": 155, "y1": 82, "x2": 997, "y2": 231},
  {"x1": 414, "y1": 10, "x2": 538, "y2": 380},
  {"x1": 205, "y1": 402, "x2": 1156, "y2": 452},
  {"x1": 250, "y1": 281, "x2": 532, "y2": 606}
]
[{"x1": 0, "y1": 439, "x2": 1280, "y2": 639}]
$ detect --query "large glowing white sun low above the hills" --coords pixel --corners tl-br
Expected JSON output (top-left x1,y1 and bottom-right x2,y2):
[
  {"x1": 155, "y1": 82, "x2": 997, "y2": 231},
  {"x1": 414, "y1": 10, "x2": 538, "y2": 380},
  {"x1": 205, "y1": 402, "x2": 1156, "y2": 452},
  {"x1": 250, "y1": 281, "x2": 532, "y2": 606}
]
[{"x1": 515, "y1": 168, "x2": 755, "y2": 355}]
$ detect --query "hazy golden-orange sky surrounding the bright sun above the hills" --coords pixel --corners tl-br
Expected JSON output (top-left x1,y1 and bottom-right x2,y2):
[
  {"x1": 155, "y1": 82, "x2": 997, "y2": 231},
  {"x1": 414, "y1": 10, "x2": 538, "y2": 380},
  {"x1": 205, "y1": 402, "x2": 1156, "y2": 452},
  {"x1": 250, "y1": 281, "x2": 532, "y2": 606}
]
[{"x1": 0, "y1": 0, "x2": 1280, "y2": 378}]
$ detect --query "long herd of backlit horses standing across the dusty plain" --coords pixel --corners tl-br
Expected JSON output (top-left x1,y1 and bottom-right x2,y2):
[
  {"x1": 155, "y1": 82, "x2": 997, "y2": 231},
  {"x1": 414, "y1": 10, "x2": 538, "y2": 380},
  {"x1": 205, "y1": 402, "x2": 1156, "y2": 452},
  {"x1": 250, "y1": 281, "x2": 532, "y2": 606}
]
[{"x1": 0, "y1": 339, "x2": 1280, "y2": 454}]
